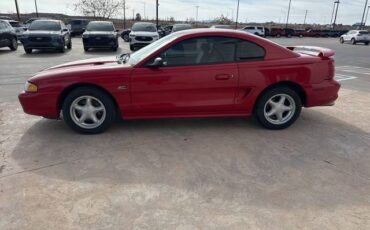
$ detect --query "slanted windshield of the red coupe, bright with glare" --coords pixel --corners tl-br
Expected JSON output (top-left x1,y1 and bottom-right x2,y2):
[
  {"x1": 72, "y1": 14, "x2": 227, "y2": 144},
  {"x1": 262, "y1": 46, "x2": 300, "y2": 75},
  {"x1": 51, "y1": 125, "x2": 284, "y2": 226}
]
[{"x1": 128, "y1": 34, "x2": 177, "y2": 65}]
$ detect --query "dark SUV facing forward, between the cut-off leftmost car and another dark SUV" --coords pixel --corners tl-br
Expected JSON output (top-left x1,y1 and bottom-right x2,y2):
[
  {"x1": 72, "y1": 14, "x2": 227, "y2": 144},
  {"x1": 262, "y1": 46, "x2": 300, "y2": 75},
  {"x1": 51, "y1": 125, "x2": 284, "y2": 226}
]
[{"x1": 21, "y1": 20, "x2": 72, "y2": 53}]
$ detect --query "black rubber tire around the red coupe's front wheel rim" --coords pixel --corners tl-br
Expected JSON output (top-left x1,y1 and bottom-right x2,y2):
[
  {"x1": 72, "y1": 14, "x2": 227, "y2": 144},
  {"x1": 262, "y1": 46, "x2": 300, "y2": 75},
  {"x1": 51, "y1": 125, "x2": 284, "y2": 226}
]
[{"x1": 62, "y1": 86, "x2": 117, "y2": 134}]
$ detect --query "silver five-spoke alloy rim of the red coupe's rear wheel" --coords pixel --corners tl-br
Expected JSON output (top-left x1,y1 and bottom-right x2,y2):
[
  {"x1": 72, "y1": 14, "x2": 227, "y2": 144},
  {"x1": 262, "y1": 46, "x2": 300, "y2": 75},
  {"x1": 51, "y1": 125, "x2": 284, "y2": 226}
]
[{"x1": 264, "y1": 94, "x2": 296, "y2": 125}]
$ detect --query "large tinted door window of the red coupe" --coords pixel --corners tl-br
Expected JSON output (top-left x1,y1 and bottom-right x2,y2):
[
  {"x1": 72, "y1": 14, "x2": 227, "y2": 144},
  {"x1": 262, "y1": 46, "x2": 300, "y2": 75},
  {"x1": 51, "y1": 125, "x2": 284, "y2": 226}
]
[{"x1": 154, "y1": 37, "x2": 236, "y2": 66}]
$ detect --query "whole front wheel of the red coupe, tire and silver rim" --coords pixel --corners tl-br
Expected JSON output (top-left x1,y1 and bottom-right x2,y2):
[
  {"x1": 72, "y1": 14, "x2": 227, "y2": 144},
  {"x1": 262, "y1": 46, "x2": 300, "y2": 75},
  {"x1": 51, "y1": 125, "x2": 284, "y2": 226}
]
[{"x1": 62, "y1": 87, "x2": 116, "y2": 134}]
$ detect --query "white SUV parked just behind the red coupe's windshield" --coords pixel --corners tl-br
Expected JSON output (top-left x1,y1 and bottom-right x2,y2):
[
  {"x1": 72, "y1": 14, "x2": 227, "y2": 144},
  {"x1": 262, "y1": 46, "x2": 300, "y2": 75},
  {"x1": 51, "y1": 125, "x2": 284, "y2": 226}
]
[{"x1": 129, "y1": 22, "x2": 159, "y2": 51}]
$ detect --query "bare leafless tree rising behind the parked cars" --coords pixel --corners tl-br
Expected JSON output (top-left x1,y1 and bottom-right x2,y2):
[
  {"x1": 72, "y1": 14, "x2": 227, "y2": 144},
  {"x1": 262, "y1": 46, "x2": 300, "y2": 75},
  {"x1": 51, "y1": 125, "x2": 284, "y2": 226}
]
[{"x1": 74, "y1": 0, "x2": 122, "y2": 18}]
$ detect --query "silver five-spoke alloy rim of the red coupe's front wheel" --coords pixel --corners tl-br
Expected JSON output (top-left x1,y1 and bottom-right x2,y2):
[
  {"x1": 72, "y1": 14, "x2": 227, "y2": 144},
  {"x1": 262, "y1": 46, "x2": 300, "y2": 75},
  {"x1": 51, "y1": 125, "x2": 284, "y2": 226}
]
[{"x1": 69, "y1": 96, "x2": 107, "y2": 129}]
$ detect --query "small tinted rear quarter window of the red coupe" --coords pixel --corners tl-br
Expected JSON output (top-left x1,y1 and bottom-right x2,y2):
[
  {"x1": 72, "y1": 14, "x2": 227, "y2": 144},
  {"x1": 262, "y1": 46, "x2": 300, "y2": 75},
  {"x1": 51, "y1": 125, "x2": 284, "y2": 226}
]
[{"x1": 236, "y1": 40, "x2": 265, "y2": 61}]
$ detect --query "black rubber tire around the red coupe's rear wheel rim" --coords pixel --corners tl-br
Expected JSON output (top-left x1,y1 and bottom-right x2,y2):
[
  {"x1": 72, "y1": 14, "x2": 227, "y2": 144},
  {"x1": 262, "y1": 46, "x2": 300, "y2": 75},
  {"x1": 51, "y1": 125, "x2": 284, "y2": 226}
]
[{"x1": 254, "y1": 86, "x2": 302, "y2": 130}]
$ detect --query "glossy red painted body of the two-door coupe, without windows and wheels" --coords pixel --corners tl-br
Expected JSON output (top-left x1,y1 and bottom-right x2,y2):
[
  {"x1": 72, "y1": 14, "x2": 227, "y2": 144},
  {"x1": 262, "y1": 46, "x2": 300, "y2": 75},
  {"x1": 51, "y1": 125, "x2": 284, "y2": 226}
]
[{"x1": 19, "y1": 30, "x2": 340, "y2": 119}]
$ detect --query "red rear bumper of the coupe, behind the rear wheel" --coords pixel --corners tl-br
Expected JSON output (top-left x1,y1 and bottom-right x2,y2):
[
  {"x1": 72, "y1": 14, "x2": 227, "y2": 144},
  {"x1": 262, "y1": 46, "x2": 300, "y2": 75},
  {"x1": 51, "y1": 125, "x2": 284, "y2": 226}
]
[{"x1": 305, "y1": 80, "x2": 340, "y2": 107}]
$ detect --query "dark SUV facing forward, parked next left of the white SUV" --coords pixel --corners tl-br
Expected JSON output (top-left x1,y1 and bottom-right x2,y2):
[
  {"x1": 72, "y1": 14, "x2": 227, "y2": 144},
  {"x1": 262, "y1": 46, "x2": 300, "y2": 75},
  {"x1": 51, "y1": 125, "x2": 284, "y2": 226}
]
[{"x1": 82, "y1": 21, "x2": 119, "y2": 51}]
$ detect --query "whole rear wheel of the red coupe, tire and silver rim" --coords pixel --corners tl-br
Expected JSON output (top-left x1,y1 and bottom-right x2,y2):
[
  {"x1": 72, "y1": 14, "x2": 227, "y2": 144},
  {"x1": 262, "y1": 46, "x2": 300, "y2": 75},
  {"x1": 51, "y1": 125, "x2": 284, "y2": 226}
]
[{"x1": 254, "y1": 87, "x2": 302, "y2": 130}]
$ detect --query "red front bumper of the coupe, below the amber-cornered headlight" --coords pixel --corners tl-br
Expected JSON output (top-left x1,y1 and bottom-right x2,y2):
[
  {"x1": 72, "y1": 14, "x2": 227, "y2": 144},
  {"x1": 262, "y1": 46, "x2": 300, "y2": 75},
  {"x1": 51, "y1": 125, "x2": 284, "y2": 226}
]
[{"x1": 18, "y1": 91, "x2": 59, "y2": 119}]
